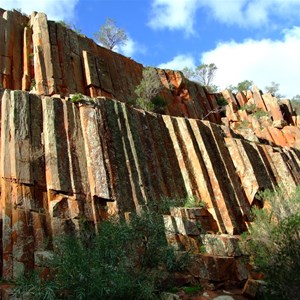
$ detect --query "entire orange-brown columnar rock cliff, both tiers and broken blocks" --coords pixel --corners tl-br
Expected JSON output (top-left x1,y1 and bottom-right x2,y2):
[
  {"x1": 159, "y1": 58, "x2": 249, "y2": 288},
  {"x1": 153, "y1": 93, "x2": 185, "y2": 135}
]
[{"x1": 0, "y1": 10, "x2": 300, "y2": 288}]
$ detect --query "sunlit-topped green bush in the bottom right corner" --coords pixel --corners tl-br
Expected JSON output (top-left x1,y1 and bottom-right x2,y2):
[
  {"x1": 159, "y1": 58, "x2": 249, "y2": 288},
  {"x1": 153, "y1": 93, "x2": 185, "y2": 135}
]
[{"x1": 244, "y1": 187, "x2": 300, "y2": 299}]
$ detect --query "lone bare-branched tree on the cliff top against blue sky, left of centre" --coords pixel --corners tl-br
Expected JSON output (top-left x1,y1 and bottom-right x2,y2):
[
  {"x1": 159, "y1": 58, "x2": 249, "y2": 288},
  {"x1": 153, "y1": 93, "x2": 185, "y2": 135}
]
[{"x1": 94, "y1": 18, "x2": 128, "y2": 50}]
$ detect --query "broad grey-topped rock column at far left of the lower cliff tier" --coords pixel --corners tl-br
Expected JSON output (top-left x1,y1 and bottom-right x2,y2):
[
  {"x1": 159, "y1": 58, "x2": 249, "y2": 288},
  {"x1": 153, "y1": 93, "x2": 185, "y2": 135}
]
[{"x1": 0, "y1": 90, "x2": 47, "y2": 279}]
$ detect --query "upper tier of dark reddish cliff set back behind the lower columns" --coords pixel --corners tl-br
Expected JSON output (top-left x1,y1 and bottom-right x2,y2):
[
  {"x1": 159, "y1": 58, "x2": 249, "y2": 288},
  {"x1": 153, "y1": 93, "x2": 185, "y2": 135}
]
[{"x1": 0, "y1": 11, "x2": 220, "y2": 122}]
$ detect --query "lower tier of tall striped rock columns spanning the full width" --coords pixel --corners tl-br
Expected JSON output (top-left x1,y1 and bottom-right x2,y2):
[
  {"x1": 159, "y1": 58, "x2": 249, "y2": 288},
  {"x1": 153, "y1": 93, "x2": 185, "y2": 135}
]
[{"x1": 0, "y1": 90, "x2": 300, "y2": 278}]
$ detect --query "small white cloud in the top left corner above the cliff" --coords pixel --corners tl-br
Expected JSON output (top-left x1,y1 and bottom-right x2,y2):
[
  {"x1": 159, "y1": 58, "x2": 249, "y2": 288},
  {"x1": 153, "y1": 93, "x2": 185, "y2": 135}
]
[{"x1": 0, "y1": 0, "x2": 79, "y2": 21}]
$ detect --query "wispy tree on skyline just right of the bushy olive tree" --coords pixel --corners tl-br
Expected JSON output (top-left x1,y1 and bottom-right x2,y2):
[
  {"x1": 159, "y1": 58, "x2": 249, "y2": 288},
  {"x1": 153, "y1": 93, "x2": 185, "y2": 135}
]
[{"x1": 182, "y1": 63, "x2": 218, "y2": 92}]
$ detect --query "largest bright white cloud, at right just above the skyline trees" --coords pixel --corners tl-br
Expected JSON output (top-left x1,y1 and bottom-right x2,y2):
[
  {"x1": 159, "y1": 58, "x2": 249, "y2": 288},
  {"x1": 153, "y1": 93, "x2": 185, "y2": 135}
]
[{"x1": 201, "y1": 27, "x2": 300, "y2": 98}]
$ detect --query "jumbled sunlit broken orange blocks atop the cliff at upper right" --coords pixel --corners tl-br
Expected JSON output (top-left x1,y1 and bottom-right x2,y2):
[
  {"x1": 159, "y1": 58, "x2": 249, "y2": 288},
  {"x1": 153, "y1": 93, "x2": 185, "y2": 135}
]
[{"x1": 222, "y1": 87, "x2": 300, "y2": 149}]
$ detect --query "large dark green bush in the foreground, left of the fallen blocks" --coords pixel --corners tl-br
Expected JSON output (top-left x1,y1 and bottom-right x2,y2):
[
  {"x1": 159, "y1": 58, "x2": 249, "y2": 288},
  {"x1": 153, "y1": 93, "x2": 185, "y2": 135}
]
[{"x1": 15, "y1": 211, "x2": 189, "y2": 299}]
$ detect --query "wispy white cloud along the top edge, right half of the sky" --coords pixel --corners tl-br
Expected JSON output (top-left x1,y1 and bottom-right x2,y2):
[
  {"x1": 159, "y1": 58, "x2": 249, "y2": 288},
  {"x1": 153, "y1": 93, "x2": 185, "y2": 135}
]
[{"x1": 148, "y1": 0, "x2": 300, "y2": 34}]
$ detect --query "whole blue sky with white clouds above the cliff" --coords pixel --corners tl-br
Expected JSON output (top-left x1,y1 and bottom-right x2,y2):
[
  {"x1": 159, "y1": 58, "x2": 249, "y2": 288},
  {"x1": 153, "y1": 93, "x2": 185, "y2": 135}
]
[{"x1": 0, "y1": 0, "x2": 300, "y2": 98}]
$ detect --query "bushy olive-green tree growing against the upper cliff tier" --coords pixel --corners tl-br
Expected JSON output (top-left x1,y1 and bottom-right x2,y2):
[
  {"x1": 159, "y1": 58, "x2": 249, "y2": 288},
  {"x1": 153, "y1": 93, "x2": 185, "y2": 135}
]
[{"x1": 135, "y1": 67, "x2": 165, "y2": 111}]
